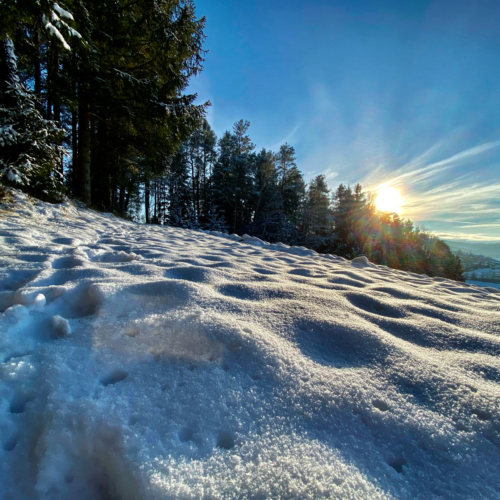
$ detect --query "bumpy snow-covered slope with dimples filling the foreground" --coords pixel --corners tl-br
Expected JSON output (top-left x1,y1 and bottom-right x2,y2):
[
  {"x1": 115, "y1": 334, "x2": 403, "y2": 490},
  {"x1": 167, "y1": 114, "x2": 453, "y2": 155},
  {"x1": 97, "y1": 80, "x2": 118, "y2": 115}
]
[{"x1": 0, "y1": 189, "x2": 500, "y2": 500}]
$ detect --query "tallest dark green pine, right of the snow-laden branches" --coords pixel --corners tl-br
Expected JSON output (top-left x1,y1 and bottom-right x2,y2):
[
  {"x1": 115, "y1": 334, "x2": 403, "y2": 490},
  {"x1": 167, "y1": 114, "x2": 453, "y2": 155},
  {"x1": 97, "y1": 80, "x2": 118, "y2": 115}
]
[{"x1": 74, "y1": 0, "x2": 206, "y2": 205}]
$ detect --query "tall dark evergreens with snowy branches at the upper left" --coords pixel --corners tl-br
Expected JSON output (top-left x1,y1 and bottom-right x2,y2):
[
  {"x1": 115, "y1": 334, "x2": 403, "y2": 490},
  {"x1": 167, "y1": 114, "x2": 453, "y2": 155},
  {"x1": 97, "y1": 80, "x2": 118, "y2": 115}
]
[{"x1": 0, "y1": 0, "x2": 208, "y2": 205}]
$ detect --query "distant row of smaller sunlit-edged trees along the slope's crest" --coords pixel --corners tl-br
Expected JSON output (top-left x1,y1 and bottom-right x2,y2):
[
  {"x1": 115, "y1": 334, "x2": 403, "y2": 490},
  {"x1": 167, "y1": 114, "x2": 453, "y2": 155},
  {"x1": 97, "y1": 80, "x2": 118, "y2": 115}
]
[{"x1": 143, "y1": 120, "x2": 463, "y2": 280}]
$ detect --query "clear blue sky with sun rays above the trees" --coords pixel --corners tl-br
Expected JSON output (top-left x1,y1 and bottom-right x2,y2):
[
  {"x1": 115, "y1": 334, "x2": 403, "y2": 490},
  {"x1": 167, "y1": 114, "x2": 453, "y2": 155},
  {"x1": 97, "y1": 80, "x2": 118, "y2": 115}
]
[{"x1": 190, "y1": 0, "x2": 500, "y2": 242}]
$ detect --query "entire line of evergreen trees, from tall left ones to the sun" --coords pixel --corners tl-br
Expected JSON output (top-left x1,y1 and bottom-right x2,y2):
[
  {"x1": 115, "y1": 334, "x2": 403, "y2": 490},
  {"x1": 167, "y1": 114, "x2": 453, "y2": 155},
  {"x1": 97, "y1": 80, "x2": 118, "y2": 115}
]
[{"x1": 0, "y1": 0, "x2": 463, "y2": 279}]
